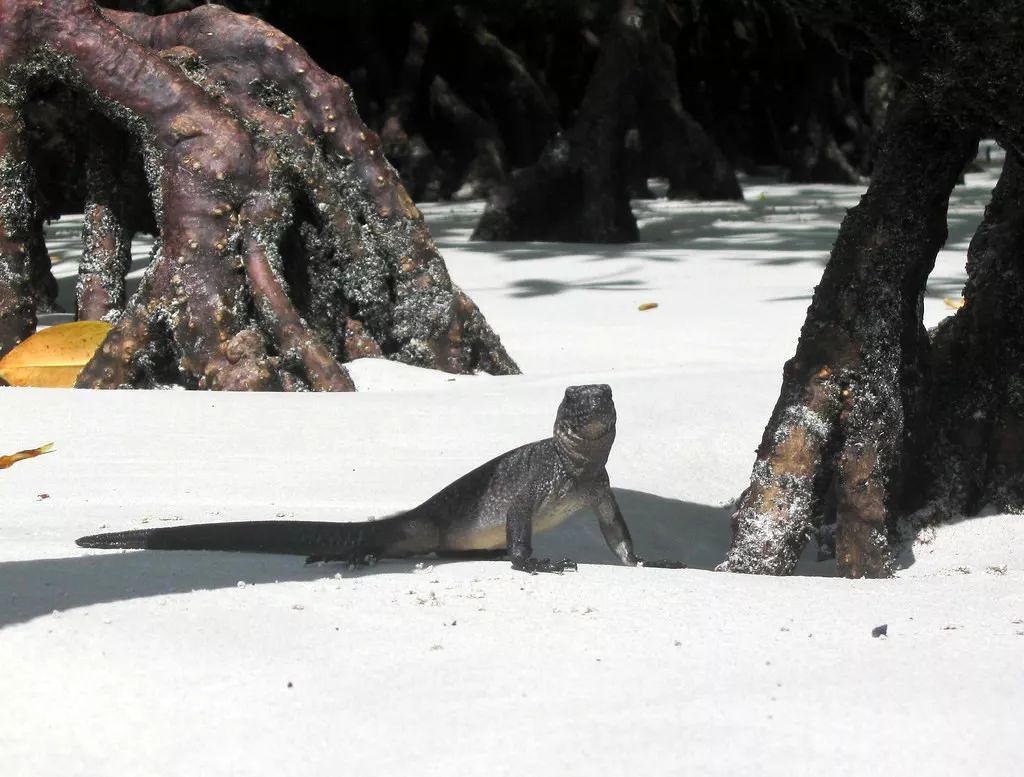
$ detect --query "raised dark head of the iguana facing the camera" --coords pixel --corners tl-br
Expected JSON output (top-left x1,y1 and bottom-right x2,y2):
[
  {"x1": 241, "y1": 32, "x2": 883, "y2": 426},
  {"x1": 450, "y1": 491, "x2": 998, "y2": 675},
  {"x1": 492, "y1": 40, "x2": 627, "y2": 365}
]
[{"x1": 554, "y1": 383, "x2": 615, "y2": 468}]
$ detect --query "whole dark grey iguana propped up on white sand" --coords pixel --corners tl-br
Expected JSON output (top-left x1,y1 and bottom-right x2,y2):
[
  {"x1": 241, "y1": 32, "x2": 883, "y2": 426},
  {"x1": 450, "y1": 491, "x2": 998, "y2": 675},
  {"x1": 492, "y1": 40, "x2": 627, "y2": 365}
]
[{"x1": 77, "y1": 385, "x2": 647, "y2": 573}]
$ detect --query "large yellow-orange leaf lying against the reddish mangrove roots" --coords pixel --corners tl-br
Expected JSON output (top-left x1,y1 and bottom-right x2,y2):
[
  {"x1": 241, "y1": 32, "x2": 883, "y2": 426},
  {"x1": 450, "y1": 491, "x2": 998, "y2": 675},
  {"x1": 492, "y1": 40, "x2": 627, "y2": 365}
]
[{"x1": 0, "y1": 321, "x2": 111, "y2": 388}]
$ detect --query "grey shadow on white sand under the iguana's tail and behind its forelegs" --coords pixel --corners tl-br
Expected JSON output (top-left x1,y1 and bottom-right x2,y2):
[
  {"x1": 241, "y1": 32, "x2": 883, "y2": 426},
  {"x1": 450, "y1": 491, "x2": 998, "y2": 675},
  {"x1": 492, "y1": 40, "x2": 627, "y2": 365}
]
[{"x1": 0, "y1": 488, "x2": 830, "y2": 629}]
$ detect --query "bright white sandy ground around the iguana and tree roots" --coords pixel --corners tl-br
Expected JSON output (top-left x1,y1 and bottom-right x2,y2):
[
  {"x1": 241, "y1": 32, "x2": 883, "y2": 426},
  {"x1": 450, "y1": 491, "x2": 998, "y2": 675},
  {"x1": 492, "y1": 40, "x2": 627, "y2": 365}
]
[{"x1": 0, "y1": 160, "x2": 1024, "y2": 777}]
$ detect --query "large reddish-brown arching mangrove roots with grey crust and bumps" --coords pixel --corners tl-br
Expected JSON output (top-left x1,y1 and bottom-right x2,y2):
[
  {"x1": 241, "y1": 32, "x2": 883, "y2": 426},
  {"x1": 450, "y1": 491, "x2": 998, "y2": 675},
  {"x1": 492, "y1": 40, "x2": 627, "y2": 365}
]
[{"x1": 0, "y1": 0, "x2": 516, "y2": 390}]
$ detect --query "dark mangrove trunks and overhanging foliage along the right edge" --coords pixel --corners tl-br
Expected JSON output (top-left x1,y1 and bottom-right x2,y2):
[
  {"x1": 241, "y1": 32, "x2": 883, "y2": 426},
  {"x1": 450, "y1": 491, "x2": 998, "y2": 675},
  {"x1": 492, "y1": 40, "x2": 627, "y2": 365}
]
[{"x1": 723, "y1": 0, "x2": 1024, "y2": 576}]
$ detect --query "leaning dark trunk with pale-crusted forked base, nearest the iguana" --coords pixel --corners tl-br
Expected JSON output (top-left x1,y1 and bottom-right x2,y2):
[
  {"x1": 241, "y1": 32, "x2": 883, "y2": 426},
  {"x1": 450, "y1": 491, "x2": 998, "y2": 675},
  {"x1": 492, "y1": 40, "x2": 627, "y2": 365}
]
[{"x1": 726, "y1": 92, "x2": 977, "y2": 576}]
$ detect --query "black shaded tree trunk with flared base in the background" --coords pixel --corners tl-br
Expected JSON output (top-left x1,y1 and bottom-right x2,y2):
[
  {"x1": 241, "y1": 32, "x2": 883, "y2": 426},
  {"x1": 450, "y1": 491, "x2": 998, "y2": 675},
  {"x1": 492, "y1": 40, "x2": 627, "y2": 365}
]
[{"x1": 473, "y1": 0, "x2": 742, "y2": 243}]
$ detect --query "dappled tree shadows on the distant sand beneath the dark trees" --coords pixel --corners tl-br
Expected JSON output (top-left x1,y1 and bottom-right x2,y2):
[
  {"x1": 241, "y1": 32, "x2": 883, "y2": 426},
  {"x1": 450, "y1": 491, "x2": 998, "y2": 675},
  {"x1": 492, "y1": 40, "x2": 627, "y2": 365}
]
[{"x1": 37, "y1": 174, "x2": 994, "y2": 315}]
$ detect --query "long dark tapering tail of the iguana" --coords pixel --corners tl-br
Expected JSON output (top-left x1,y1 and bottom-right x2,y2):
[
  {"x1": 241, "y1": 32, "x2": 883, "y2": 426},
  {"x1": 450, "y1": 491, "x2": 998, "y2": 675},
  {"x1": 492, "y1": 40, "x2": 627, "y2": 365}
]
[{"x1": 75, "y1": 516, "x2": 419, "y2": 560}]
